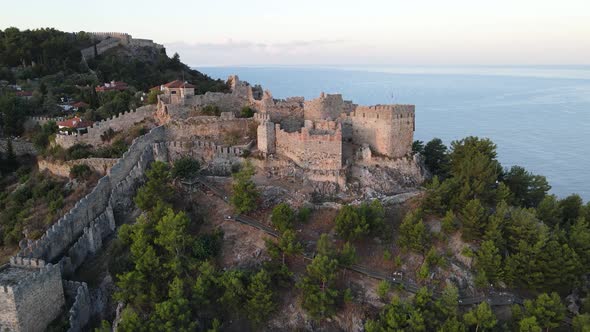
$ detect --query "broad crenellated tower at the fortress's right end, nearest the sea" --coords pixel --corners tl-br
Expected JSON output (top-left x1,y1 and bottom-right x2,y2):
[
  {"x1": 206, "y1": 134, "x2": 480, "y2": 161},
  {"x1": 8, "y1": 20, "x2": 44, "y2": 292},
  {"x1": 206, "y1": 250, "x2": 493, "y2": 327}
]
[{"x1": 348, "y1": 105, "x2": 415, "y2": 158}]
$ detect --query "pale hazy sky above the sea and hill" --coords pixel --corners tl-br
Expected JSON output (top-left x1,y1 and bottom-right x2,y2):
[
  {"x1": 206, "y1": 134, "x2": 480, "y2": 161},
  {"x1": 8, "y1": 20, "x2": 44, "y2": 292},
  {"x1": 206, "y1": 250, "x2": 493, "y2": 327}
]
[{"x1": 0, "y1": 0, "x2": 590, "y2": 66}]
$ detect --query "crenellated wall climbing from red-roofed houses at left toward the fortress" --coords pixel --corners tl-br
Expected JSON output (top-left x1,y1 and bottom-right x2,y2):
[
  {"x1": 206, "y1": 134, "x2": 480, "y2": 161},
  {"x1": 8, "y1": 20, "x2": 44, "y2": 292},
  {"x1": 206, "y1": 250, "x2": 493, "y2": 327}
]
[{"x1": 55, "y1": 105, "x2": 155, "y2": 149}]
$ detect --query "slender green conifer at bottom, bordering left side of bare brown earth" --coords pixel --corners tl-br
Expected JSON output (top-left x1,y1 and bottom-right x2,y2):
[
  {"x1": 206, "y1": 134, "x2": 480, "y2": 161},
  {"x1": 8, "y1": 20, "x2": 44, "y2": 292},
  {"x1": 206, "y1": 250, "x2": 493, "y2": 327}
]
[{"x1": 246, "y1": 269, "x2": 275, "y2": 324}]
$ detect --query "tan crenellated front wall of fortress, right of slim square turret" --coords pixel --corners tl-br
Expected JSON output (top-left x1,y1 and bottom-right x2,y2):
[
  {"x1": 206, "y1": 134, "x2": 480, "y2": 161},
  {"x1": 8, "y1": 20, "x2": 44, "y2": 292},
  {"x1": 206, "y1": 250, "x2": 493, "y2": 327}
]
[{"x1": 275, "y1": 122, "x2": 342, "y2": 171}]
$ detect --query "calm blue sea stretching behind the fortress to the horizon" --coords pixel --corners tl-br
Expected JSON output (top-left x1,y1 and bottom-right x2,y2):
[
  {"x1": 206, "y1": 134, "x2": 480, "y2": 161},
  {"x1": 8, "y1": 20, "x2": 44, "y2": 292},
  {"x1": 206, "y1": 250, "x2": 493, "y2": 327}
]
[{"x1": 197, "y1": 67, "x2": 590, "y2": 200}]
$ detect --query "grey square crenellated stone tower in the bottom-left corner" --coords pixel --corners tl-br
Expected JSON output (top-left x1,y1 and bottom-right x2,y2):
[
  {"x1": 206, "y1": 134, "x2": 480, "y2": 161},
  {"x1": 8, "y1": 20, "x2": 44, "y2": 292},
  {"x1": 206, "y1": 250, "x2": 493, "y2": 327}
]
[{"x1": 0, "y1": 257, "x2": 65, "y2": 332}]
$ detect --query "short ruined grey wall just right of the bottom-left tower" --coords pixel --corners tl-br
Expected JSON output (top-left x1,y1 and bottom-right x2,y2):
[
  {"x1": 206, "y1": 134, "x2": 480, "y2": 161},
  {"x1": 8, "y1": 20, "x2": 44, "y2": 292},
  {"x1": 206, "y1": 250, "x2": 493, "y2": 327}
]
[{"x1": 63, "y1": 280, "x2": 92, "y2": 332}]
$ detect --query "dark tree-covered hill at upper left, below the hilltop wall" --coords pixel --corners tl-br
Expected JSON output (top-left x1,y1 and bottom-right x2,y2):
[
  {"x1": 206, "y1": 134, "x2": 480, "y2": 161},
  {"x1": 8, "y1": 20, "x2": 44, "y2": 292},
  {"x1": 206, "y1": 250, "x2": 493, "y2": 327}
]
[{"x1": 0, "y1": 28, "x2": 227, "y2": 93}]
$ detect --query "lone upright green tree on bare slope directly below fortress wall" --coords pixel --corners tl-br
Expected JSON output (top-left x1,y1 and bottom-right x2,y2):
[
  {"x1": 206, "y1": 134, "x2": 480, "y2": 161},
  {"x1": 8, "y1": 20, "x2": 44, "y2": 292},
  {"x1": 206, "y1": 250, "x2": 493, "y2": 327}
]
[{"x1": 230, "y1": 162, "x2": 260, "y2": 213}]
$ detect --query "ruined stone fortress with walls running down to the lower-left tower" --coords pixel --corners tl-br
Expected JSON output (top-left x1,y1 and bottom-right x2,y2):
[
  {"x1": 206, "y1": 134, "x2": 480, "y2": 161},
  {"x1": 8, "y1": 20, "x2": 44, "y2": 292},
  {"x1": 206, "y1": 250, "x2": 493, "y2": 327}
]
[{"x1": 0, "y1": 76, "x2": 423, "y2": 331}]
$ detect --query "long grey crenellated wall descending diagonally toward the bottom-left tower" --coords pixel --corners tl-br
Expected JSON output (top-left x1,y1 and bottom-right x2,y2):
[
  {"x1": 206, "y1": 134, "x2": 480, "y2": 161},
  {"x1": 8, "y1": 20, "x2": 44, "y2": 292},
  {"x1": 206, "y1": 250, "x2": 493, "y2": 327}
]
[{"x1": 18, "y1": 127, "x2": 164, "y2": 267}]
